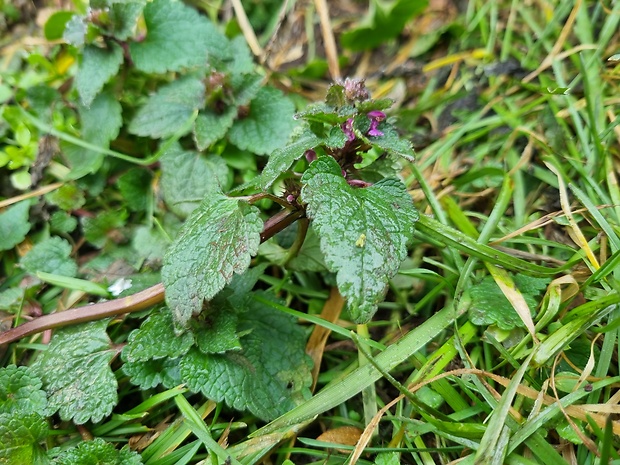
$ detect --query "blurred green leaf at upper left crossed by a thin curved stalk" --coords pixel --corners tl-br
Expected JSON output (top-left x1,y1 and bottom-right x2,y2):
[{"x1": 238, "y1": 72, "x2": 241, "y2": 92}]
[{"x1": 61, "y1": 92, "x2": 123, "y2": 179}]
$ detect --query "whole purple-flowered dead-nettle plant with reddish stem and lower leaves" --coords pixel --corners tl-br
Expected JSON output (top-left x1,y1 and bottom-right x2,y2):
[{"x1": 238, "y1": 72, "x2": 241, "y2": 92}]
[{"x1": 0, "y1": 79, "x2": 418, "y2": 423}]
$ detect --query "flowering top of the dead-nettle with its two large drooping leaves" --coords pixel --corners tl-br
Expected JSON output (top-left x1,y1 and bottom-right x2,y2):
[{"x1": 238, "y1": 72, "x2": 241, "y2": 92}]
[{"x1": 162, "y1": 79, "x2": 418, "y2": 328}]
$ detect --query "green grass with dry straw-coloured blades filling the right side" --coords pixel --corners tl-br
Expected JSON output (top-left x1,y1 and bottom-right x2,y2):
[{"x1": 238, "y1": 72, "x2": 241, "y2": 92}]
[{"x1": 1, "y1": 0, "x2": 620, "y2": 465}]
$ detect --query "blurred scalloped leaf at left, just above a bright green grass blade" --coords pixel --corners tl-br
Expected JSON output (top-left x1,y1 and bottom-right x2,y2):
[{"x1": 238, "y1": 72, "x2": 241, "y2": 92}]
[{"x1": 21, "y1": 236, "x2": 77, "y2": 277}]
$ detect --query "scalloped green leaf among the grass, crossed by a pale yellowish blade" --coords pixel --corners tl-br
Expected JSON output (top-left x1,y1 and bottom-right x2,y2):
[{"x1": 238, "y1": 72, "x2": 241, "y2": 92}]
[{"x1": 464, "y1": 275, "x2": 549, "y2": 331}]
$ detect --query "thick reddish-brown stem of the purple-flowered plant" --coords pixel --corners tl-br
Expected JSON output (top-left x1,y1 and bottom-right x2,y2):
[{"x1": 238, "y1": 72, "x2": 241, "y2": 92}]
[{"x1": 0, "y1": 210, "x2": 304, "y2": 345}]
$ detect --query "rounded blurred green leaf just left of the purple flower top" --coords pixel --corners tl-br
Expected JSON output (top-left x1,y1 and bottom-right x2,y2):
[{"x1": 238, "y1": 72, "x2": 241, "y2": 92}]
[{"x1": 228, "y1": 87, "x2": 296, "y2": 155}]
